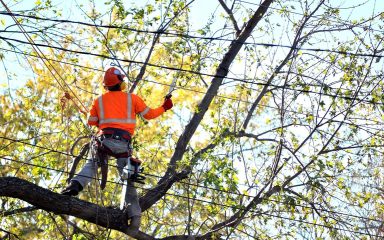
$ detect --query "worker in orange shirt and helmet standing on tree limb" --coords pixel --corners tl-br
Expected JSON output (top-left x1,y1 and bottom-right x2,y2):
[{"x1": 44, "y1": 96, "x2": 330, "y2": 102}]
[{"x1": 62, "y1": 67, "x2": 173, "y2": 230}]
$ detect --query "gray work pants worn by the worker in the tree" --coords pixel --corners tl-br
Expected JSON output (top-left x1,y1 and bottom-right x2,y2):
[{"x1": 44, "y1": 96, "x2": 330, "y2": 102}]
[{"x1": 72, "y1": 138, "x2": 141, "y2": 218}]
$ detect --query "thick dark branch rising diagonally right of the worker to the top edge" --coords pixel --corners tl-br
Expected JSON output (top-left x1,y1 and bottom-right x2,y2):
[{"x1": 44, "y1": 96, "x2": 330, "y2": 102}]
[{"x1": 140, "y1": 0, "x2": 273, "y2": 211}]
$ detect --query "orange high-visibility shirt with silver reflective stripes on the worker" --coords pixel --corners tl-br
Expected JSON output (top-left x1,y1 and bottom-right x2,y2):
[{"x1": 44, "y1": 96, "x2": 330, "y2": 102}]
[{"x1": 88, "y1": 91, "x2": 164, "y2": 135}]
